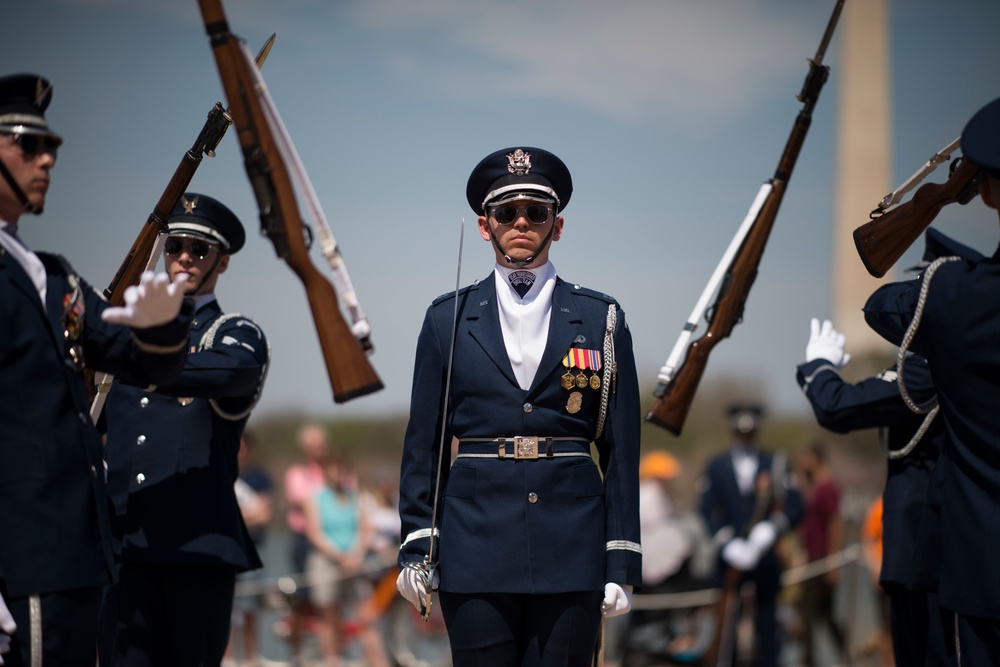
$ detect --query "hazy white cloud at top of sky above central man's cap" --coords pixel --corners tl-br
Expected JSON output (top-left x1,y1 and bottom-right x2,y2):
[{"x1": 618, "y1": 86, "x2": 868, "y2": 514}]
[{"x1": 344, "y1": 0, "x2": 825, "y2": 130}]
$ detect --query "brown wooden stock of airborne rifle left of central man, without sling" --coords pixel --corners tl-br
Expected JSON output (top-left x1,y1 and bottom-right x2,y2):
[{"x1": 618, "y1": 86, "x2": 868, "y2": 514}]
[{"x1": 199, "y1": 0, "x2": 383, "y2": 403}]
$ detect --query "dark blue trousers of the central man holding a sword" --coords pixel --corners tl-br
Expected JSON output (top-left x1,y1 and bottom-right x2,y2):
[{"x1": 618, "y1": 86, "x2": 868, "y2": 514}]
[{"x1": 439, "y1": 591, "x2": 604, "y2": 667}]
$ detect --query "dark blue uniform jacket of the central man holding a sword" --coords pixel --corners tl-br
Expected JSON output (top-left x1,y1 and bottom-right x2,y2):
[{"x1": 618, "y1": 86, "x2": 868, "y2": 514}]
[{"x1": 399, "y1": 274, "x2": 642, "y2": 594}]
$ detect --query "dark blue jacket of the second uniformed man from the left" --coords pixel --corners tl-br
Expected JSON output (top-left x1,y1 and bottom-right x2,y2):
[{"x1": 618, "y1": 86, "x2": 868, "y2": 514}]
[{"x1": 105, "y1": 301, "x2": 268, "y2": 570}]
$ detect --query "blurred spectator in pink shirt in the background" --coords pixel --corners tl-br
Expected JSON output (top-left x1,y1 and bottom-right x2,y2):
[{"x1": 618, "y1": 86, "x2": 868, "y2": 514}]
[{"x1": 284, "y1": 423, "x2": 330, "y2": 662}]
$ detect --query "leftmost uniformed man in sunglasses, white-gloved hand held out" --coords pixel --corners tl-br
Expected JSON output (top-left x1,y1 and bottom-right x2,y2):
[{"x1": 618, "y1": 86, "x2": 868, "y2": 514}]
[{"x1": 0, "y1": 74, "x2": 190, "y2": 667}]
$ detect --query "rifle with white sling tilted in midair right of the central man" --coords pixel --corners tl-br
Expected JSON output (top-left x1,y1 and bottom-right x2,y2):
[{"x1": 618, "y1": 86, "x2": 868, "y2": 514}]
[{"x1": 646, "y1": 0, "x2": 844, "y2": 435}]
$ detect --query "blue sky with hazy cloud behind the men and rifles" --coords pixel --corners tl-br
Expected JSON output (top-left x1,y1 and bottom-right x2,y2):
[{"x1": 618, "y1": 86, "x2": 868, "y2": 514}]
[{"x1": 7, "y1": 0, "x2": 1000, "y2": 428}]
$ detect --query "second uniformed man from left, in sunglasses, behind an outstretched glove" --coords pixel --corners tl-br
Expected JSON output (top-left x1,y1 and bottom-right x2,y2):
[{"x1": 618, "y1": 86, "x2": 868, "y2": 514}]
[{"x1": 101, "y1": 192, "x2": 269, "y2": 667}]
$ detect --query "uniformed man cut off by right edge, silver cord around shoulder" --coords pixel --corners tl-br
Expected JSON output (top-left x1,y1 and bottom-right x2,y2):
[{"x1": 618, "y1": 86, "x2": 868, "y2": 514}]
[{"x1": 865, "y1": 99, "x2": 1000, "y2": 667}]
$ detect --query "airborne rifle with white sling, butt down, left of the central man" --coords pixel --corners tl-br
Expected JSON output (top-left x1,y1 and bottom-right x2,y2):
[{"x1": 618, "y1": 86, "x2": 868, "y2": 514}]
[{"x1": 198, "y1": 0, "x2": 382, "y2": 403}]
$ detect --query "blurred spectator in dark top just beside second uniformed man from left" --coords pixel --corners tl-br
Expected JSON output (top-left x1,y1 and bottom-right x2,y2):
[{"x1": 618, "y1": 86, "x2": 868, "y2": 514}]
[{"x1": 223, "y1": 431, "x2": 274, "y2": 667}]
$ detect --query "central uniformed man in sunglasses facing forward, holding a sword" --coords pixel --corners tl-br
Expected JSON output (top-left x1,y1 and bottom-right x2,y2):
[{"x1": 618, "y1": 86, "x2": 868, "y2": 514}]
[{"x1": 397, "y1": 146, "x2": 641, "y2": 667}]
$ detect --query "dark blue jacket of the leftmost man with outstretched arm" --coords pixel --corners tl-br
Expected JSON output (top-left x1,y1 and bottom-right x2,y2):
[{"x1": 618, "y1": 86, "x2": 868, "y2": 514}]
[{"x1": 0, "y1": 248, "x2": 190, "y2": 596}]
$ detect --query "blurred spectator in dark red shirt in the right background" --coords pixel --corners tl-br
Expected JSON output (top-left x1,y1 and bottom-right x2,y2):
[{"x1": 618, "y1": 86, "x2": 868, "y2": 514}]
[{"x1": 798, "y1": 442, "x2": 846, "y2": 667}]
